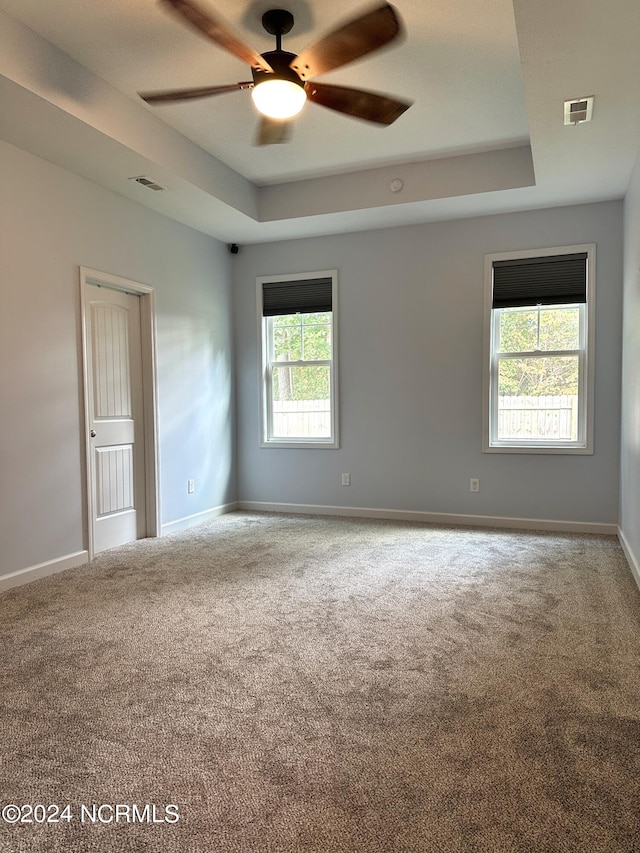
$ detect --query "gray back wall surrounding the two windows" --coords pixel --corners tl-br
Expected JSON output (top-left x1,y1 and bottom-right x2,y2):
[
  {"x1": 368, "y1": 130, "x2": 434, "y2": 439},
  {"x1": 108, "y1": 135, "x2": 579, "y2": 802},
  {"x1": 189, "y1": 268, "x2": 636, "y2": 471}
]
[{"x1": 233, "y1": 202, "x2": 622, "y2": 524}]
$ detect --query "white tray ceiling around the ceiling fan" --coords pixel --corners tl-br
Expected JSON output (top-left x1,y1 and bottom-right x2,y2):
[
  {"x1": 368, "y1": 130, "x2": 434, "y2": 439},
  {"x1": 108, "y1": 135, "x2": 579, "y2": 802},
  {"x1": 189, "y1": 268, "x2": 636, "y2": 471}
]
[{"x1": 0, "y1": 0, "x2": 640, "y2": 243}]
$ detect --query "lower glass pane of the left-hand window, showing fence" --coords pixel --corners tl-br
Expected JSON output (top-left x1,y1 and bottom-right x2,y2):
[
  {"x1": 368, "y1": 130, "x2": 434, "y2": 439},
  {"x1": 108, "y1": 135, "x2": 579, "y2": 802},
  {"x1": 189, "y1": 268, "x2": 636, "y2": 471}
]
[{"x1": 272, "y1": 365, "x2": 331, "y2": 438}]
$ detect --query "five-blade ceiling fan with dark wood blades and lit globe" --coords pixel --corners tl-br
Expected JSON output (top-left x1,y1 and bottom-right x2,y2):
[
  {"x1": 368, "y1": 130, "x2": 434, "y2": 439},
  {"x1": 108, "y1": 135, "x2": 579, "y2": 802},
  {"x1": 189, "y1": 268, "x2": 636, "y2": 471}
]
[{"x1": 140, "y1": 0, "x2": 411, "y2": 145}]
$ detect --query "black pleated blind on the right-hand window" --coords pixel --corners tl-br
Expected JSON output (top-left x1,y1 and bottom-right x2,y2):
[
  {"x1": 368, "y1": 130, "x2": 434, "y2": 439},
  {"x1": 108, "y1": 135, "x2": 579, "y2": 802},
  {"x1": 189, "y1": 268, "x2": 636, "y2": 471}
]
[{"x1": 492, "y1": 252, "x2": 587, "y2": 308}]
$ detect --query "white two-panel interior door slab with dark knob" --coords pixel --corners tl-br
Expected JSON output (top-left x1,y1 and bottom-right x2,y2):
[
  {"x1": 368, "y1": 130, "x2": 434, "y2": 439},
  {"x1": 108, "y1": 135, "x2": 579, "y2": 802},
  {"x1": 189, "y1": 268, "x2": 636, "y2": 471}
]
[{"x1": 84, "y1": 283, "x2": 146, "y2": 553}]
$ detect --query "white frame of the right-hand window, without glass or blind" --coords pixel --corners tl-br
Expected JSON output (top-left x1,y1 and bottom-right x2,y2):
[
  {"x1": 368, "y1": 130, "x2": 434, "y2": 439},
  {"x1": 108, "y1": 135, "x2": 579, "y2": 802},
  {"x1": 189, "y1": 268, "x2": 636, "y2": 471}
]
[{"x1": 482, "y1": 243, "x2": 596, "y2": 455}]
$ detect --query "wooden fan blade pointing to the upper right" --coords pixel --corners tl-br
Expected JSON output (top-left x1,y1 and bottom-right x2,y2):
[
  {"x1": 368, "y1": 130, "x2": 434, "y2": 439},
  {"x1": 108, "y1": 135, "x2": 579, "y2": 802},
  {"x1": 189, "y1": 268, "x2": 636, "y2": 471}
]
[{"x1": 291, "y1": 3, "x2": 401, "y2": 80}]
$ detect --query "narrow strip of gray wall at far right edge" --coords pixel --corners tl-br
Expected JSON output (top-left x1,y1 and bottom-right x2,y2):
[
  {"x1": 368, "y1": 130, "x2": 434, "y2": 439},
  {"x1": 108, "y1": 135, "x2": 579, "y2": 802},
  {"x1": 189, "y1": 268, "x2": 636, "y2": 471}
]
[{"x1": 620, "y1": 158, "x2": 640, "y2": 583}]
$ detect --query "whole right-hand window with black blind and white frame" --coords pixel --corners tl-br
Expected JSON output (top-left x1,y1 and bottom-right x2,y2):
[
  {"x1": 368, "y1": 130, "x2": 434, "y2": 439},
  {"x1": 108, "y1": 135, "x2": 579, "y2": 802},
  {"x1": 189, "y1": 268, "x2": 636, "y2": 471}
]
[{"x1": 484, "y1": 245, "x2": 595, "y2": 453}]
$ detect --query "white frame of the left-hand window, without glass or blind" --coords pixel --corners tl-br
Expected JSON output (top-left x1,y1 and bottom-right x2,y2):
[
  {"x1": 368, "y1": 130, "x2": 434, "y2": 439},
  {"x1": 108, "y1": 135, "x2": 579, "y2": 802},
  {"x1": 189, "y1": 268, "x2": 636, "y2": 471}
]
[{"x1": 256, "y1": 270, "x2": 340, "y2": 450}]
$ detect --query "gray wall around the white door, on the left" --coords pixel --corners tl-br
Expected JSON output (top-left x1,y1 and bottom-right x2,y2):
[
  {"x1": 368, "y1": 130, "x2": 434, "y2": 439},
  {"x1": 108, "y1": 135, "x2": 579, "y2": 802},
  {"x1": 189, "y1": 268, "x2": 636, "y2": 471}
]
[{"x1": 0, "y1": 143, "x2": 236, "y2": 576}]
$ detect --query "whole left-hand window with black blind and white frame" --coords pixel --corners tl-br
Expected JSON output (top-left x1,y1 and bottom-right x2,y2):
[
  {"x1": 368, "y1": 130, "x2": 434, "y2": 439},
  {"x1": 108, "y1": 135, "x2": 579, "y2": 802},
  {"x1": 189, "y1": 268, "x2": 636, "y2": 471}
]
[{"x1": 257, "y1": 270, "x2": 338, "y2": 448}]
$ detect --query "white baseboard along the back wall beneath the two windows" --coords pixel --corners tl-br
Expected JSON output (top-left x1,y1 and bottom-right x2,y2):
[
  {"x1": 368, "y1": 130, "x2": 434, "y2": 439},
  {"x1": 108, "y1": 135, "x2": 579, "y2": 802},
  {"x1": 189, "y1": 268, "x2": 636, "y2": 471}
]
[{"x1": 237, "y1": 501, "x2": 618, "y2": 536}]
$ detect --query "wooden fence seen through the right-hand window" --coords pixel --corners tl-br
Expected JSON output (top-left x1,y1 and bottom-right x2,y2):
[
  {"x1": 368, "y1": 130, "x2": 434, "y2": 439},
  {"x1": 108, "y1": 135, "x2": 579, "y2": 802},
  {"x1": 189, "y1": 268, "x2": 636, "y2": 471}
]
[{"x1": 498, "y1": 394, "x2": 578, "y2": 441}]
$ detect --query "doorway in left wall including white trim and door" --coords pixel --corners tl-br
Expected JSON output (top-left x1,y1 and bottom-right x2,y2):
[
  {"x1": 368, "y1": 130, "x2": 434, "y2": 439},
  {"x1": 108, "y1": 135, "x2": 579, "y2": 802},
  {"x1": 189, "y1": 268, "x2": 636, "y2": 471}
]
[{"x1": 80, "y1": 267, "x2": 160, "y2": 560}]
